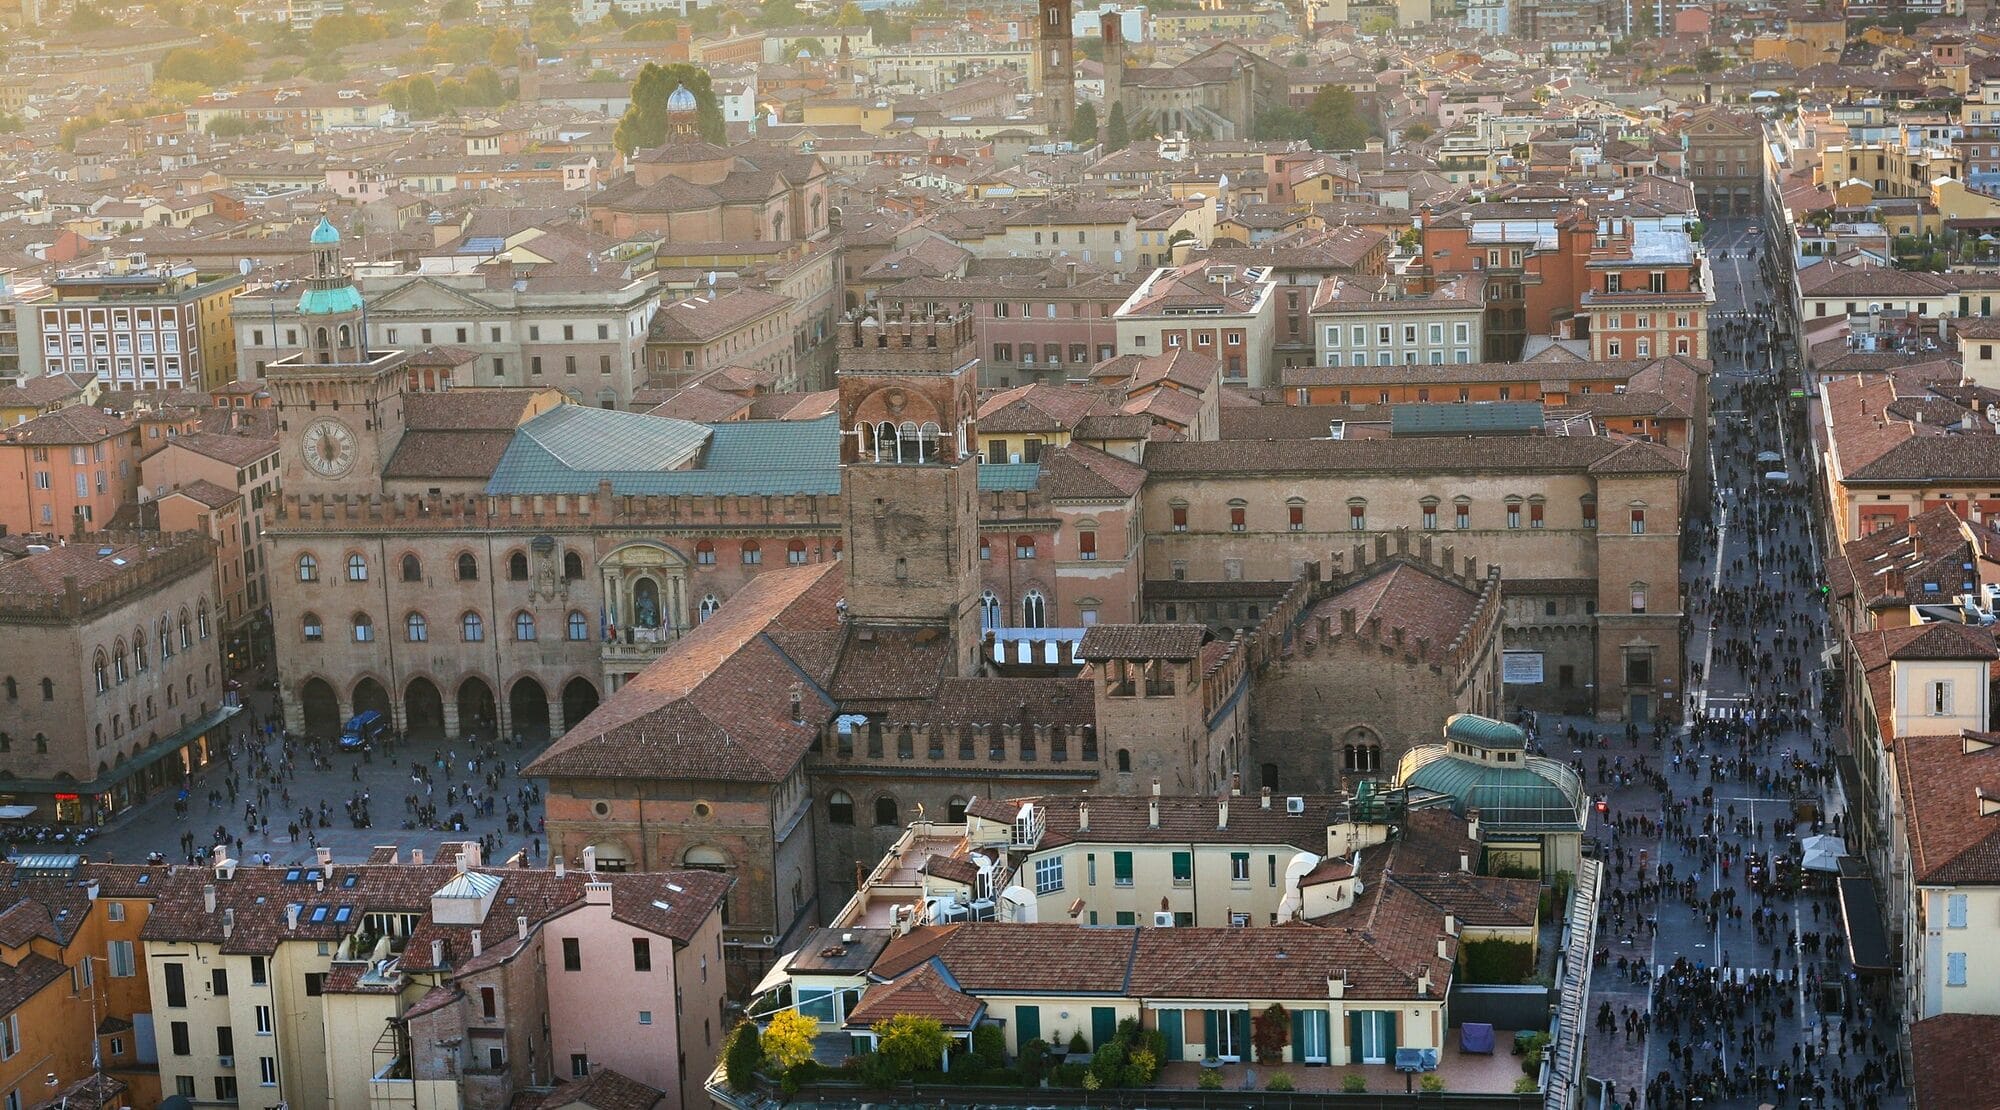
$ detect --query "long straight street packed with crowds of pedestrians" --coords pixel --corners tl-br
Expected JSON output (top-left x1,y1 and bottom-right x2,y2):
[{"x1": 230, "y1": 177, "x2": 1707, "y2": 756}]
[{"x1": 1584, "y1": 220, "x2": 1902, "y2": 1110}]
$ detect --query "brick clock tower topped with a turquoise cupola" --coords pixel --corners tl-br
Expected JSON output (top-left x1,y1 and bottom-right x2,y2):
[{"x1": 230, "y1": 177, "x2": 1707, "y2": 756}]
[{"x1": 264, "y1": 218, "x2": 408, "y2": 496}]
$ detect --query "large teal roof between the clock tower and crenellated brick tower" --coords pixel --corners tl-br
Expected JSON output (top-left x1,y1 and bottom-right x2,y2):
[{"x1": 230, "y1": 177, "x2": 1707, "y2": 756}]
[{"x1": 486, "y1": 406, "x2": 840, "y2": 496}]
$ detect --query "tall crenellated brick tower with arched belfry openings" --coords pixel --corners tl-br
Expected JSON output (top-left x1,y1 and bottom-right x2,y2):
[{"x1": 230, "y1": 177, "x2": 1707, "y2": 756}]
[{"x1": 836, "y1": 308, "x2": 982, "y2": 676}]
